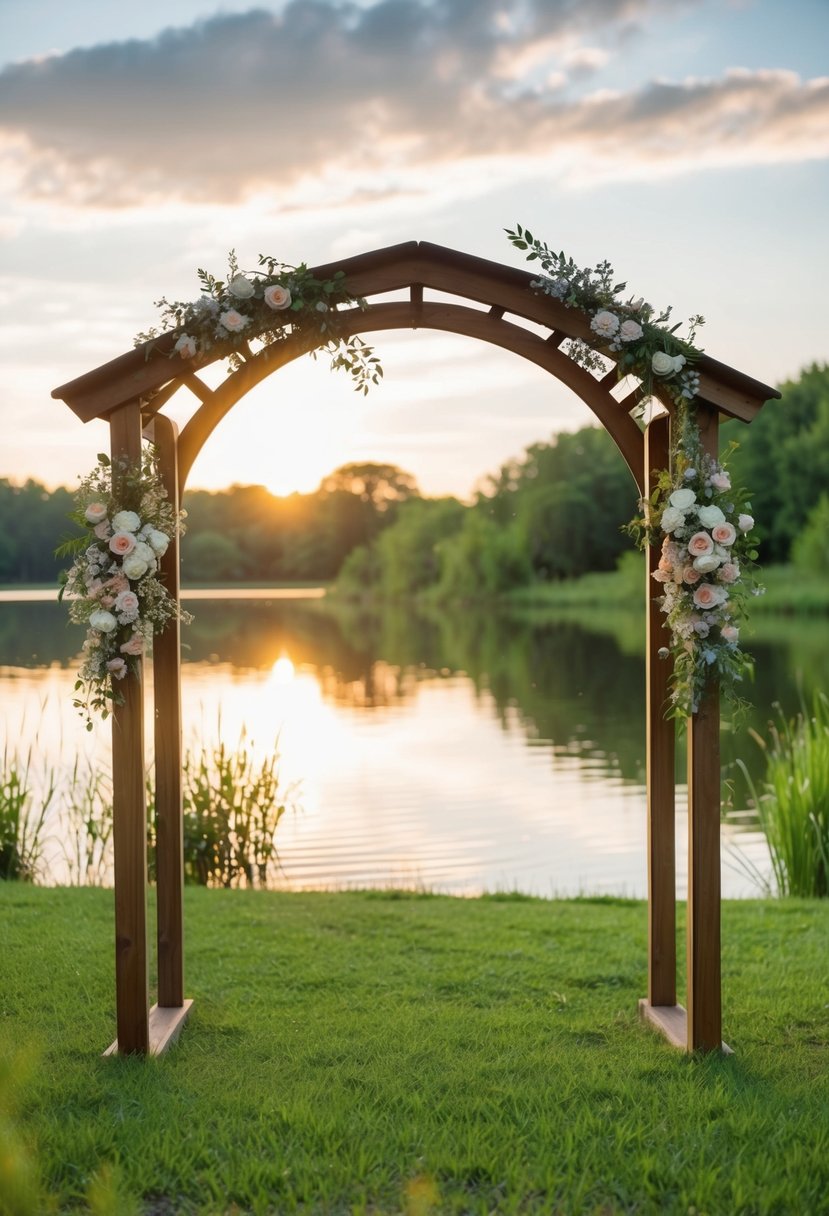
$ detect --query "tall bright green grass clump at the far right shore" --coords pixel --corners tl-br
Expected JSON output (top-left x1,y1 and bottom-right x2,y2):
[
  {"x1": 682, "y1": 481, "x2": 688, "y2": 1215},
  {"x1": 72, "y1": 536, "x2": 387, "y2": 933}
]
[{"x1": 738, "y1": 693, "x2": 829, "y2": 897}]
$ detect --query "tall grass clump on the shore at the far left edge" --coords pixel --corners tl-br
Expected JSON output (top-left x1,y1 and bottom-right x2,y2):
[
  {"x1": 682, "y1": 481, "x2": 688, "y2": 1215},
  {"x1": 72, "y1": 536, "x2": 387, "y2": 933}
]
[{"x1": 0, "y1": 742, "x2": 57, "y2": 883}]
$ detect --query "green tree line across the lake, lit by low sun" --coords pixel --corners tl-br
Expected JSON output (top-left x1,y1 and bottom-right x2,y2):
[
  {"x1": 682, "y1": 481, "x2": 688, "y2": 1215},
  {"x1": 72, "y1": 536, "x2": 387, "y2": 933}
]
[{"x1": 0, "y1": 364, "x2": 829, "y2": 590}]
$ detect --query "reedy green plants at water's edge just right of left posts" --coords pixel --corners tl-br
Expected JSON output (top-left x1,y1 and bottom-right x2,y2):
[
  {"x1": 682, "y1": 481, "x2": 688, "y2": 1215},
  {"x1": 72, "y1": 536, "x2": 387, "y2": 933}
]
[{"x1": 147, "y1": 730, "x2": 291, "y2": 886}]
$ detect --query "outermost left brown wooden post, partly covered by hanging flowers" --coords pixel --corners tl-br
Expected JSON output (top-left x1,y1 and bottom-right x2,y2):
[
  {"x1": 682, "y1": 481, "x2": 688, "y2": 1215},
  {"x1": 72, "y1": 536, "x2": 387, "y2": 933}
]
[{"x1": 109, "y1": 401, "x2": 150, "y2": 1054}]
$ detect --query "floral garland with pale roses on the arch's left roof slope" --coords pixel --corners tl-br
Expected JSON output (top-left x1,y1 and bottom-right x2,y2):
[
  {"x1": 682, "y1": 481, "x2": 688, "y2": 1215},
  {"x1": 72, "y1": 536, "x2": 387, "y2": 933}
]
[{"x1": 135, "y1": 249, "x2": 383, "y2": 393}]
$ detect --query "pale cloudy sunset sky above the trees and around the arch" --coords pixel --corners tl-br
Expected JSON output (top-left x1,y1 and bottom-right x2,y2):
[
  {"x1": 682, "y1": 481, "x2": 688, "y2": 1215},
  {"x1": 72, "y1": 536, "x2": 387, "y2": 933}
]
[{"x1": 0, "y1": 0, "x2": 829, "y2": 496}]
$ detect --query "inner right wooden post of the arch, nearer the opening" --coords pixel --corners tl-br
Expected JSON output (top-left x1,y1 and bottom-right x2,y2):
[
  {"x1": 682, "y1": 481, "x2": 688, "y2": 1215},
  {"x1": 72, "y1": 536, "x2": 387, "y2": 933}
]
[{"x1": 644, "y1": 416, "x2": 676, "y2": 1006}]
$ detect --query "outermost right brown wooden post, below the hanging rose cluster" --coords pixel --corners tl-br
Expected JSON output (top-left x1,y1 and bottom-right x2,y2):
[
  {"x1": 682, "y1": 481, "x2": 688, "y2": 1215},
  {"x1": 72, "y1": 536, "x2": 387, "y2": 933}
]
[{"x1": 687, "y1": 405, "x2": 722, "y2": 1052}]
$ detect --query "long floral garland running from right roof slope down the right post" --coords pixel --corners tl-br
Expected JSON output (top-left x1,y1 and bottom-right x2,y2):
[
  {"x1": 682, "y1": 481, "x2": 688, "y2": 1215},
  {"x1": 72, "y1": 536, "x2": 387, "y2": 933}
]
[{"x1": 507, "y1": 224, "x2": 762, "y2": 716}]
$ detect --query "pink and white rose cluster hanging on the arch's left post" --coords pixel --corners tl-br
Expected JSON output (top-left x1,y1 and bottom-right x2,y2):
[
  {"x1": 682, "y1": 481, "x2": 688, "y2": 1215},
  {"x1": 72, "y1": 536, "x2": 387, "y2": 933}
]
[{"x1": 56, "y1": 447, "x2": 192, "y2": 730}]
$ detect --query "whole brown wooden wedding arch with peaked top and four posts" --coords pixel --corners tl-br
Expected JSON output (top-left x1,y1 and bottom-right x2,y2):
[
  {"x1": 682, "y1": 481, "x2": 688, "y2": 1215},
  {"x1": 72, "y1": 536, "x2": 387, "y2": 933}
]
[{"x1": 52, "y1": 241, "x2": 779, "y2": 1053}]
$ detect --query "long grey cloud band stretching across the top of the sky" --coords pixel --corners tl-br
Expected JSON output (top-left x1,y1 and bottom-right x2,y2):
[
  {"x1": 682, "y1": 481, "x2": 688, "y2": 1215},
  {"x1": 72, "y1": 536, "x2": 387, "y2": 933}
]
[{"x1": 0, "y1": 0, "x2": 829, "y2": 207}]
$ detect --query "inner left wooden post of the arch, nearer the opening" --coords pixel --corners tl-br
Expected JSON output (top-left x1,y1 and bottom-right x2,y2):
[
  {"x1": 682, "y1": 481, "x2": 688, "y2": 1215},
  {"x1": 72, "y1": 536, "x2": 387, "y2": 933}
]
[{"x1": 153, "y1": 415, "x2": 185, "y2": 1008}]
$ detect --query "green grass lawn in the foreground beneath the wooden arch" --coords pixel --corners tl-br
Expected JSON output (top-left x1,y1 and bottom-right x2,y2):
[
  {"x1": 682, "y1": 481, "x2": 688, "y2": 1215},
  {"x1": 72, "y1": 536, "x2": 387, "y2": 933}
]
[{"x1": 0, "y1": 884, "x2": 829, "y2": 1216}]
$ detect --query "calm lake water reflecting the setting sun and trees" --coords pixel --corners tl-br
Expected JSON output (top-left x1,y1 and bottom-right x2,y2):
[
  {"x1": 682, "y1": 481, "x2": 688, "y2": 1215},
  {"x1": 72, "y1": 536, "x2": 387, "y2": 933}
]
[{"x1": 0, "y1": 592, "x2": 829, "y2": 895}]
